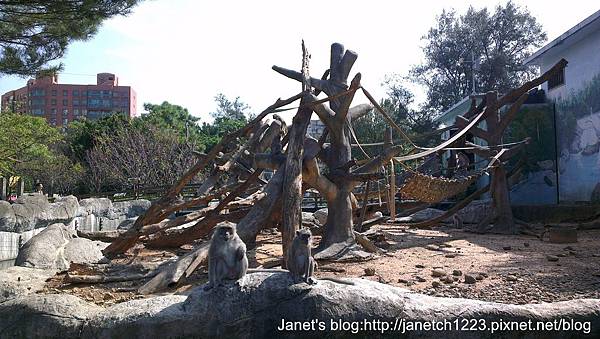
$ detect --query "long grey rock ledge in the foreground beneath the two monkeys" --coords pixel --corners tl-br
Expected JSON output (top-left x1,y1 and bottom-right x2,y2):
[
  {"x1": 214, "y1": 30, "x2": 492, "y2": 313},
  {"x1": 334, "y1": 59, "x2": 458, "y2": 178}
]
[{"x1": 0, "y1": 273, "x2": 600, "y2": 339}]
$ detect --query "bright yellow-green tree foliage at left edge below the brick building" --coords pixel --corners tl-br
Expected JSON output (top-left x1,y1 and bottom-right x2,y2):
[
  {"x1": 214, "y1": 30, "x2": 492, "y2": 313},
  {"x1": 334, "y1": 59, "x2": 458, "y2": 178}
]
[{"x1": 0, "y1": 112, "x2": 61, "y2": 176}]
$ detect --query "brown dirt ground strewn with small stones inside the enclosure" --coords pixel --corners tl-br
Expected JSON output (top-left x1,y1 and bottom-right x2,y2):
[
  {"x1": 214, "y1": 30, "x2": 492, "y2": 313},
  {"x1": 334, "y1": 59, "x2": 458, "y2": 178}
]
[{"x1": 44, "y1": 225, "x2": 600, "y2": 305}]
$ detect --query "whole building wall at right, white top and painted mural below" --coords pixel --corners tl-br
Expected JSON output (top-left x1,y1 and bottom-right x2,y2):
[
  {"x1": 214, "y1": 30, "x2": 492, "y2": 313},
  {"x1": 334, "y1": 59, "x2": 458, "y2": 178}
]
[{"x1": 539, "y1": 29, "x2": 600, "y2": 203}]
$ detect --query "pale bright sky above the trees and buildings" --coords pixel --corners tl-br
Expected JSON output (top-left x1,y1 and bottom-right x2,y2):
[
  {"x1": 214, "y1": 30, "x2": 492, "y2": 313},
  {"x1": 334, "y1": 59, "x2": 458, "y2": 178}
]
[{"x1": 0, "y1": 0, "x2": 600, "y2": 121}]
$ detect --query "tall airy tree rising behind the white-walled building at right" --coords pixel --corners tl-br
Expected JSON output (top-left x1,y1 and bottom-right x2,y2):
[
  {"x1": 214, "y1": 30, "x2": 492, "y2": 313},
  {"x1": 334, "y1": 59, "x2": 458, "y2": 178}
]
[{"x1": 411, "y1": 1, "x2": 546, "y2": 112}]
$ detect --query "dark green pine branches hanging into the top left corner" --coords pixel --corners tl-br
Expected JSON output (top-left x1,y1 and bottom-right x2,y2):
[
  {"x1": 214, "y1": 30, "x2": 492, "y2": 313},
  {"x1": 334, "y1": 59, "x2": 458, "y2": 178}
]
[{"x1": 0, "y1": 0, "x2": 139, "y2": 76}]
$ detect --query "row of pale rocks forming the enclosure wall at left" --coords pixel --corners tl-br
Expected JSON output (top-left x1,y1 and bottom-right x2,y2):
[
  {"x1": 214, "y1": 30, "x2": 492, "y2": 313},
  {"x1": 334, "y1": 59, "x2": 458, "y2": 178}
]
[{"x1": 0, "y1": 194, "x2": 150, "y2": 268}]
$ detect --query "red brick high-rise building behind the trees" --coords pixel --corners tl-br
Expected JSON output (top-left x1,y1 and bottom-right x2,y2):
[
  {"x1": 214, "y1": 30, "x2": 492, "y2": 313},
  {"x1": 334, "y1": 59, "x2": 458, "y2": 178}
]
[{"x1": 2, "y1": 73, "x2": 137, "y2": 126}]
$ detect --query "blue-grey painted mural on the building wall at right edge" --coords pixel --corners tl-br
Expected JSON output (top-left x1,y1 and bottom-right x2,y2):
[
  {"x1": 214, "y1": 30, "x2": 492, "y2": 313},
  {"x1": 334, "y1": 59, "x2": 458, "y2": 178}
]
[{"x1": 556, "y1": 74, "x2": 600, "y2": 203}]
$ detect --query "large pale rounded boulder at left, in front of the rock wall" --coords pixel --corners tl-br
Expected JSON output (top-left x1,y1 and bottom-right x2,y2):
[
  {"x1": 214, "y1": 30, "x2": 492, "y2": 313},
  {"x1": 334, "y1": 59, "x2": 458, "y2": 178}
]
[{"x1": 15, "y1": 224, "x2": 106, "y2": 270}]
